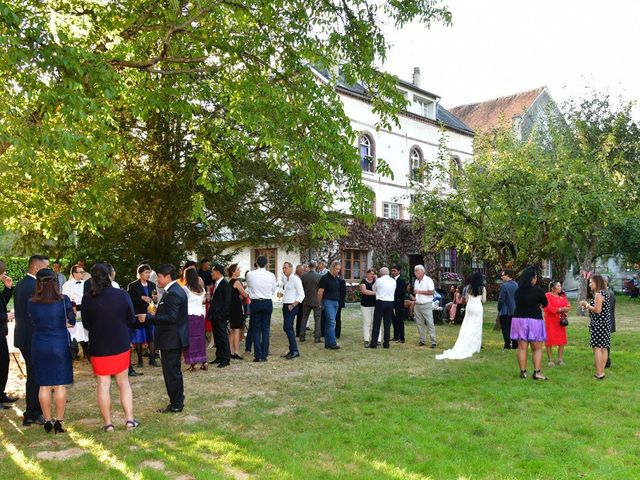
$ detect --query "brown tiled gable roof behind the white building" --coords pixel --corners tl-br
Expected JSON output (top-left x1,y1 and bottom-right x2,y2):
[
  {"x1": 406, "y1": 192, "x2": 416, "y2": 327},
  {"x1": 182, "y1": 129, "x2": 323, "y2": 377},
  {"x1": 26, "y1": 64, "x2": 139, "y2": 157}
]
[{"x1": 450, "y1": 87, "x2": 546, "y2": 132}]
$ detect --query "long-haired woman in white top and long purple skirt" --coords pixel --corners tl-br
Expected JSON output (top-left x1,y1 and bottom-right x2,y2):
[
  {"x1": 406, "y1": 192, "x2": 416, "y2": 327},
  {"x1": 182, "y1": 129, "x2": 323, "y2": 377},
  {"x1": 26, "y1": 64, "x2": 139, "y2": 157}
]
[{"x1": 183, "y1": 266, "x2": 208, "y2": 372}]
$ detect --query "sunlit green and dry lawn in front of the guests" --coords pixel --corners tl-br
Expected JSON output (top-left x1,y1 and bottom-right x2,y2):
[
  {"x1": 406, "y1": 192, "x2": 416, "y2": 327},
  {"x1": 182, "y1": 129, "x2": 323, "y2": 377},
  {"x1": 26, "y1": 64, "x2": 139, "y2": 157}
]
[{"x1": 0, "y1": 299, "x2": 640, "y2": 480}]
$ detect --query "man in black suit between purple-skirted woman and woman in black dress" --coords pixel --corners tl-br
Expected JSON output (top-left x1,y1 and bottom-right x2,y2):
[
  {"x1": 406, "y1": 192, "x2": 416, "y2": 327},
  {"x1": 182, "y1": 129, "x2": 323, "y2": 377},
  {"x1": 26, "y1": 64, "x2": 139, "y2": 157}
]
[{"x1": 209, "y1": 263, "x2": 231, "y2": 368}]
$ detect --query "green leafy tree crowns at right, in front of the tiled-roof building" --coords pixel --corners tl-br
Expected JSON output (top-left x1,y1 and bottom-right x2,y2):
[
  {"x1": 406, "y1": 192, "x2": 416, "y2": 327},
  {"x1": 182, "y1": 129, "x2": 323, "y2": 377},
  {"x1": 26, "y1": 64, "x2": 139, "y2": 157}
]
[{"x1": 414, "y1": 92, "x2": 640, "y2": 295}]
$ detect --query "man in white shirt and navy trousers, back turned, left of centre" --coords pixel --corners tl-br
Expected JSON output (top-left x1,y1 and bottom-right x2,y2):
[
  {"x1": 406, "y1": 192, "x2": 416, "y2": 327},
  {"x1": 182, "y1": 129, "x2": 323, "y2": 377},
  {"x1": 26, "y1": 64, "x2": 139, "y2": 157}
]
[{"x1": 247, "y1": 255, "x2": 278, "y2": 362}]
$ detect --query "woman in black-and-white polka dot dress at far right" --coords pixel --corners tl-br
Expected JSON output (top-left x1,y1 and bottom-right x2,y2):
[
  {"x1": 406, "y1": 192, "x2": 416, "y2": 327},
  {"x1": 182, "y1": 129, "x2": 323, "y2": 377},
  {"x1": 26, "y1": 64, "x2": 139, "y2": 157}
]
[{"x1": 580, "y1": 273, "x2": 611, "y2": 380}]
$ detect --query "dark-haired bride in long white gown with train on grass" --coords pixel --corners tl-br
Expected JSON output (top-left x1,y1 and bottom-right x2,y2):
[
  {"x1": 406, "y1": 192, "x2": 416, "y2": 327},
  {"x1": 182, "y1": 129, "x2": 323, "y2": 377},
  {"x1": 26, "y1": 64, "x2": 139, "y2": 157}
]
[{"x1": 436, "y1": 272, "x2": 487, "y2": 360}]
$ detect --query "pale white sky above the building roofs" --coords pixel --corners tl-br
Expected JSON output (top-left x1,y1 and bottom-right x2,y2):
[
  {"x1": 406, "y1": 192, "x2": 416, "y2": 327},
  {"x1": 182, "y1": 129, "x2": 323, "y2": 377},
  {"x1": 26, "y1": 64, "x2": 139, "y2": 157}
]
[{"x1": 382, "y1": 0, "x2": 640, "y2": 120}]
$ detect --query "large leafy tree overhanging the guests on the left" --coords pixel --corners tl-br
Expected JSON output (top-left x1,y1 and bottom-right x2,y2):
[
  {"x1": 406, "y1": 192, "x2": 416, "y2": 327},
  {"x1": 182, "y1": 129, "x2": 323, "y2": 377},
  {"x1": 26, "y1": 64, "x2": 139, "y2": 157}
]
[{"x1": 0, "y1": 0, "x2": 450, "y2": 274}]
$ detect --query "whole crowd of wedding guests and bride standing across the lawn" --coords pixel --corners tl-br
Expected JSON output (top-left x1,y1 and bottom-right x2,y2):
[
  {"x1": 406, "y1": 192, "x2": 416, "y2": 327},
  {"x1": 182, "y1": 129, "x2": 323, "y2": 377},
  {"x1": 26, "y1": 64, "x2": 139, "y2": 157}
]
[{"x1": 0, "y1": 255, "x2": 615, "y2": 433}]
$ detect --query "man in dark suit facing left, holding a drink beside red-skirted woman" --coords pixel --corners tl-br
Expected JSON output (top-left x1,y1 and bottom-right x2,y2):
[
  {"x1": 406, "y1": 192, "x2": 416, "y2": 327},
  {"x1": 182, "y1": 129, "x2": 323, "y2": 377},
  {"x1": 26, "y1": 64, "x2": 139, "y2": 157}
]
[{"x1": 137, "y1": 264, "x2": 189, "y2": 413}]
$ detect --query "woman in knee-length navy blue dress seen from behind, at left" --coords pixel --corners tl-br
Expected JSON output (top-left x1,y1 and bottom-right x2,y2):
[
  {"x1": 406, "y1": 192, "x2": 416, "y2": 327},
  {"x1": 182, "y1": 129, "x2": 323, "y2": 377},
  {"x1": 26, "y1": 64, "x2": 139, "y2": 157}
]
[{"x1": 27, "y1": 268, "x2": 76, "y2": 433}]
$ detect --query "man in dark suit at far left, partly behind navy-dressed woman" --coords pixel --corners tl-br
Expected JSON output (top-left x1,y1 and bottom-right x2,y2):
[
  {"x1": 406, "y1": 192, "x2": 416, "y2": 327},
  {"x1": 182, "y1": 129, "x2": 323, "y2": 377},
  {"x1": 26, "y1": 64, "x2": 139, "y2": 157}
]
[{"x1": 13, "y1": 255, "x2": 49, "y2": 427}]
